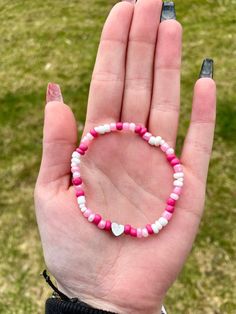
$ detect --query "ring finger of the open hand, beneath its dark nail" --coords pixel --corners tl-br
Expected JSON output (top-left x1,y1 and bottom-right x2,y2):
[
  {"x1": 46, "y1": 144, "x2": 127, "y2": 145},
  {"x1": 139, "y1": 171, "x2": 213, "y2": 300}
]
[{"x1": 149, "y1": 9, "x2": 182, "y2": 147}]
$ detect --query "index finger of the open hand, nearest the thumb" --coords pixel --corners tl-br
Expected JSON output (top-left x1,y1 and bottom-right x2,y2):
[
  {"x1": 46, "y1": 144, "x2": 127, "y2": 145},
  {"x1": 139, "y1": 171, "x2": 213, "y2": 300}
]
[{"x1": 86, "y1": 2, "x2": 134, "y2": 129}]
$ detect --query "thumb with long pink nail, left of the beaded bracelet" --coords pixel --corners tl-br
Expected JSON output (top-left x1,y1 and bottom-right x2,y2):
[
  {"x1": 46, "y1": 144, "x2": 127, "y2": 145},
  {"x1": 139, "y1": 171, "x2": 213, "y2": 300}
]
[{"x1": 37, "y1": 84, "x2": 77, "y2": 189}]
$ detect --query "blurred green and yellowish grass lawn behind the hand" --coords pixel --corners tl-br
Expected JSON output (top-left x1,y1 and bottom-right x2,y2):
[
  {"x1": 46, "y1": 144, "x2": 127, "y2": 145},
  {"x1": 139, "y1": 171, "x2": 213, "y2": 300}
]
[{"x1": 0, "y1": 0, "x2": 236, "y2": 314}]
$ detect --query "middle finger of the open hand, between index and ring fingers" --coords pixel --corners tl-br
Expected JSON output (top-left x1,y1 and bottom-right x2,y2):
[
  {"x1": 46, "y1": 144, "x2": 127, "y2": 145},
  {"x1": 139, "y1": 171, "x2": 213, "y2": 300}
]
[{"x1": 122, "y1": 0, "x2": 162, "y2": 124}]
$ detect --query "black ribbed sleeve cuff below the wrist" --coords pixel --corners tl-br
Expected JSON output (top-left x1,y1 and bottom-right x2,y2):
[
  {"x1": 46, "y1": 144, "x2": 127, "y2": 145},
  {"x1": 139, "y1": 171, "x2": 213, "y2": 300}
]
[{"x1": 45, "y1": 298, "x2": 116, "y2": 314}]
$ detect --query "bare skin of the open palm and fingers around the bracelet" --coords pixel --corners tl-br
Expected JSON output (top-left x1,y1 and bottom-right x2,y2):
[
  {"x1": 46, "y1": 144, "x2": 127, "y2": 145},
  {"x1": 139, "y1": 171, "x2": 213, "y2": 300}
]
[{"x1": 35, "y1": 0, "x2": 216, "y2": 314}]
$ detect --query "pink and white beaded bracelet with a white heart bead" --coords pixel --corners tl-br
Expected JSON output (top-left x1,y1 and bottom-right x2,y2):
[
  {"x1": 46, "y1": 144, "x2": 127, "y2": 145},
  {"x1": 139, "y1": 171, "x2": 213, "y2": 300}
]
[{"x1": 71, "y1": 122, "x2": 184, "y2": 238}]
